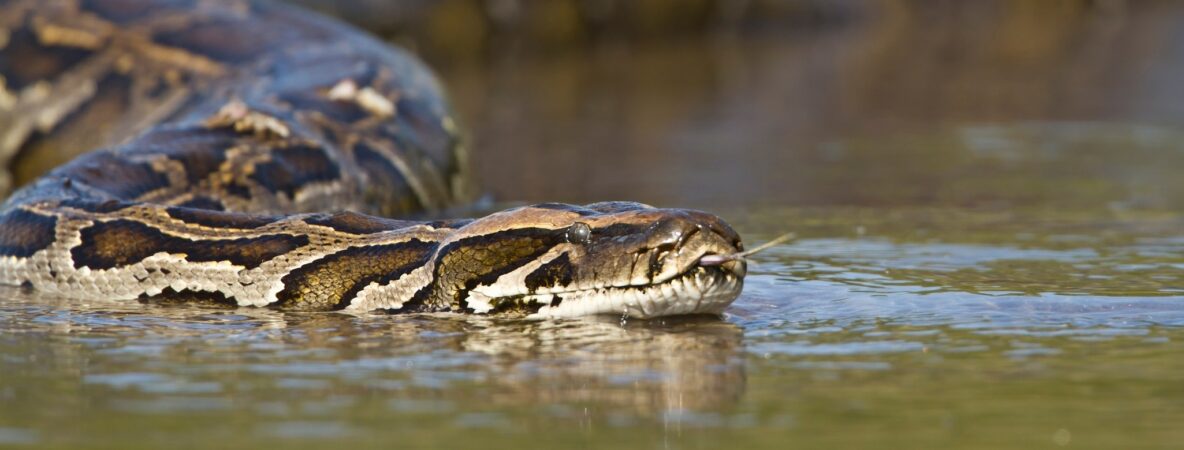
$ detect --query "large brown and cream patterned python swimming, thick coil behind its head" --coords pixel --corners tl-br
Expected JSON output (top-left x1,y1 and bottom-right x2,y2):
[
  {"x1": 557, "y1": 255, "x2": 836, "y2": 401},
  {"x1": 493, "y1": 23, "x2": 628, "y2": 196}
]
[{"x1": 0, "y1": 0, "x2": 745, "y2": 317}]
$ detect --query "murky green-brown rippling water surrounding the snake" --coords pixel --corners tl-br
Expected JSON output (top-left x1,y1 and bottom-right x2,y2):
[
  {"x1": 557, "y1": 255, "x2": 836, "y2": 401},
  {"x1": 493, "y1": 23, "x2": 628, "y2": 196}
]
[{"x1": 0, "y1": 1, "x2": 1184, "y2": 449}]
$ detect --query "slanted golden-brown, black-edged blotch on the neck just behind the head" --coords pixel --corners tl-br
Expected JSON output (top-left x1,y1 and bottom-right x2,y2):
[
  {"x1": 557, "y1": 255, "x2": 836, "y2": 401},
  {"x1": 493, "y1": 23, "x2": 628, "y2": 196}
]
[{"x1": 276, "y1": 239, "x2": 436, "y2": 310}]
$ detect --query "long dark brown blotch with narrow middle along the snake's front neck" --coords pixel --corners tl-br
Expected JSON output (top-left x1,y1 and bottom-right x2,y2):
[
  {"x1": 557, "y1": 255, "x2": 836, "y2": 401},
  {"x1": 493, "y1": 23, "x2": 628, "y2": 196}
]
[{"x1": 70, "y1": 220, "x2": 308, "y2": 270}]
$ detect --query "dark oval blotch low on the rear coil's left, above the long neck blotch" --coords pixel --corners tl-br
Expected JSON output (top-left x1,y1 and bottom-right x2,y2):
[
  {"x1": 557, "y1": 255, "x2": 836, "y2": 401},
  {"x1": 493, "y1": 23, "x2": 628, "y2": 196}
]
[{"x1": 63, "y1": 152, "x2": 169, "y2": 200}]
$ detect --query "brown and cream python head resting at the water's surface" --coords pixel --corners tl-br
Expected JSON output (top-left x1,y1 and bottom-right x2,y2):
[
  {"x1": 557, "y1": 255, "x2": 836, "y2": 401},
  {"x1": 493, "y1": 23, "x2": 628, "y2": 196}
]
[{"x1": 433, "y1": 201, "x2": 746, "y2": 317}]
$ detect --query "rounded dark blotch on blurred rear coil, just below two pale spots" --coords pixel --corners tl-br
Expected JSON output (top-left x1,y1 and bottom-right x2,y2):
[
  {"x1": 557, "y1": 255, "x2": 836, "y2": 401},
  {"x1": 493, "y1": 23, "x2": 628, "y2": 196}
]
[{"x1": 251, "y1": 146, "x2": 341, "y2": 199}]
